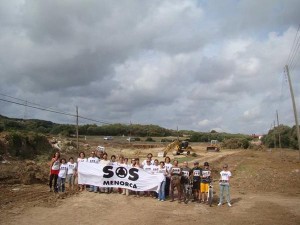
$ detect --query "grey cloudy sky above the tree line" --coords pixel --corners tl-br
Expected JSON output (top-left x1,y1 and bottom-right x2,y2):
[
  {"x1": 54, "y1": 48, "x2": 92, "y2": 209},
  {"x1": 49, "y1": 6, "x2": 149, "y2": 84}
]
[{"x1": 0, "y1": 0, "x2": 300, "y2": 134}]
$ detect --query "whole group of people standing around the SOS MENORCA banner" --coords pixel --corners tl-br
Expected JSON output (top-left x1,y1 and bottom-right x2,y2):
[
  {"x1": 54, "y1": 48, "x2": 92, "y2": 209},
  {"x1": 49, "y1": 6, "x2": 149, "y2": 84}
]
[{"x1": 49, "y1": 151, "x2": 231, "y2": 206}]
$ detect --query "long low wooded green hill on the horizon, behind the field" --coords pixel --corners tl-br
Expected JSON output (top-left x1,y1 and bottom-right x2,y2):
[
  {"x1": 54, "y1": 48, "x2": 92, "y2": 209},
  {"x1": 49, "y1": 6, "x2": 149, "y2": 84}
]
[{"x1": 0, "y1": 115, "x2": 251, "y2": 142}]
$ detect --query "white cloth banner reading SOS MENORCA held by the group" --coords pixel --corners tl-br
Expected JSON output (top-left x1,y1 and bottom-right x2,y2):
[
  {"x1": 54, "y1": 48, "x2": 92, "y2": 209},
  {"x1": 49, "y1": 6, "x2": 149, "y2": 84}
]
[{"x1": 78, "y1": 162, "x2": 164, "y2": 191}]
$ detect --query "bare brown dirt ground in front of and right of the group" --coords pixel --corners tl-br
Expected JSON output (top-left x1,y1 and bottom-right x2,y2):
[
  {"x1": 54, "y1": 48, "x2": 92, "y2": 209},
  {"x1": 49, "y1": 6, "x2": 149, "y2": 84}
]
[{"x1": 0, "y1": 146, "x2": 300, "y2": 225}]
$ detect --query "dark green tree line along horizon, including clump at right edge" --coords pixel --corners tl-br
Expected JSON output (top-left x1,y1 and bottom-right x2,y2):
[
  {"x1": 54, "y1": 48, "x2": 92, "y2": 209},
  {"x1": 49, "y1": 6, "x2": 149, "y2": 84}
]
[{"x1": 0, "y1": 115, "x2": 298, "y2": 149}]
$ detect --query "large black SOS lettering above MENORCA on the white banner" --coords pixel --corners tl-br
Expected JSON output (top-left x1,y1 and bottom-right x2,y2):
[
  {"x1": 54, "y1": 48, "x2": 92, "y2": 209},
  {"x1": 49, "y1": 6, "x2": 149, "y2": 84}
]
[{"x1": 103, "y1": 166, "x2": 139, "y2": 181}]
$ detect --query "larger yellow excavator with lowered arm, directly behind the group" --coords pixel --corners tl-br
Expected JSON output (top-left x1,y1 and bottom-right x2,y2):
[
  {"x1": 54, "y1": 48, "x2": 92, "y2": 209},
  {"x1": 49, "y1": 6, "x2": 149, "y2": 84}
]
[{"x1": 158, "y1": 139, "x2": 192, "y2": 157}]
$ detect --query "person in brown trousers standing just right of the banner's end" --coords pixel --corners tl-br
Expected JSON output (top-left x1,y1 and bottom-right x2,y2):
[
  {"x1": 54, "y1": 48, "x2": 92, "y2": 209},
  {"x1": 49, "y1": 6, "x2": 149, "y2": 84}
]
[{"x1": 170, "y1": 160, "x2": 182, "y2": 203}]
